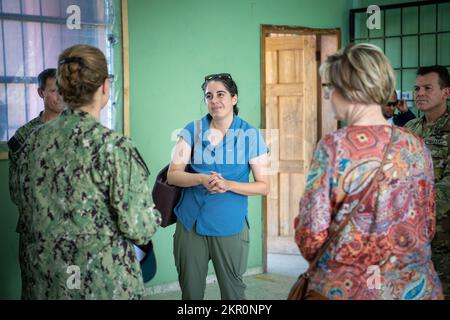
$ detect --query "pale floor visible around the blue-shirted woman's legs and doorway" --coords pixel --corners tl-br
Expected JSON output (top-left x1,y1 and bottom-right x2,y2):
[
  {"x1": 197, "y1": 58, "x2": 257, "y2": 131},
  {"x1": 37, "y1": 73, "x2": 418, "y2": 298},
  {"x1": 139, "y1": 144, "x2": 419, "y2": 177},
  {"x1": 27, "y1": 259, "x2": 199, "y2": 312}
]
[{"x1": 148, "y1": 254, "x2": 307, "y2": 300}]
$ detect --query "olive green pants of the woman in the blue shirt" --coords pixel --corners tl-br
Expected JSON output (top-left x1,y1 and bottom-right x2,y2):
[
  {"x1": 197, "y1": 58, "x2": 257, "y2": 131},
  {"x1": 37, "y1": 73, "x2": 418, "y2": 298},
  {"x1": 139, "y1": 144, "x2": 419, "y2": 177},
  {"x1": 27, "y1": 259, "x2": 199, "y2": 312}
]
[{"x1": 173, "y1": 221, "x2": 249, "y2": 300}]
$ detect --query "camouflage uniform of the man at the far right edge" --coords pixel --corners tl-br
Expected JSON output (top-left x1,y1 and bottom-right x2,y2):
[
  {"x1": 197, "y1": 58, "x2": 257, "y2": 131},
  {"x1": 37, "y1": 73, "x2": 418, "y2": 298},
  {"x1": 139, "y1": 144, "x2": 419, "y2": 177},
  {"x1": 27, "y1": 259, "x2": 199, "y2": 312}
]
[{"x1": 405, "y1": 108, "x2": 450, "y2": 299}]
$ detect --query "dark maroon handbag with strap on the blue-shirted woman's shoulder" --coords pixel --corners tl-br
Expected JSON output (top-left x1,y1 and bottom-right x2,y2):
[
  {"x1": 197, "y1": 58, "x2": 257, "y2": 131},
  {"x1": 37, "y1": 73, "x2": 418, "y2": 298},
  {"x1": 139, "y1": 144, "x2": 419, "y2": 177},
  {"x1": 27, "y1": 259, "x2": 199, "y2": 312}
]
[{"x1": 152, "y1": 120, "x2": 200, "y2": 228}]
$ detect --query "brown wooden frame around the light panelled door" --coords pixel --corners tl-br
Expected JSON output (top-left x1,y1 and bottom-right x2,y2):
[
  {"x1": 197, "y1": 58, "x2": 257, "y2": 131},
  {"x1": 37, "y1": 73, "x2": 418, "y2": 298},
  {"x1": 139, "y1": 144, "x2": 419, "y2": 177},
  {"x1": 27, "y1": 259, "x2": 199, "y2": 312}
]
[{"x1": 261, "y1": 24, "x2": 342, "y2": 273}]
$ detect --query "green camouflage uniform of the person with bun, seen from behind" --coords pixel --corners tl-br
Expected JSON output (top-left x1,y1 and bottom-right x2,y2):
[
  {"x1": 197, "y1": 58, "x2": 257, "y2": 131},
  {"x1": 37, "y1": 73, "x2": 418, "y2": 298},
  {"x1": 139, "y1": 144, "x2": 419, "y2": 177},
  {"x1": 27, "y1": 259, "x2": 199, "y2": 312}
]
[{"x1": 12, "y1": 110, "x2": 161, "y2": 299}]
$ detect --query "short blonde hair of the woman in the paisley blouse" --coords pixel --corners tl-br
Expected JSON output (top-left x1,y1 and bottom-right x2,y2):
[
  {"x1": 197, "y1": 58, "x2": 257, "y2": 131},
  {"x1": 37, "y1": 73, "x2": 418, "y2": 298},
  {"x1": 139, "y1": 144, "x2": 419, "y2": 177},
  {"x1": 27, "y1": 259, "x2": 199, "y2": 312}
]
[{"x1": 319, "y1": 43, "x2": 395, "y2": 105}]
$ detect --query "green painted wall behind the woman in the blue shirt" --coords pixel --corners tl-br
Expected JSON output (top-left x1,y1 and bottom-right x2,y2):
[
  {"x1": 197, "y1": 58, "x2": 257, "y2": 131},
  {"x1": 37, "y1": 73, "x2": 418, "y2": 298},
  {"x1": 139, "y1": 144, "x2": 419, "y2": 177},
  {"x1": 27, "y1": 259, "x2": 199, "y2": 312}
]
[{"x1": 0, "y1": 0, "x2": 352, "y2": 299}]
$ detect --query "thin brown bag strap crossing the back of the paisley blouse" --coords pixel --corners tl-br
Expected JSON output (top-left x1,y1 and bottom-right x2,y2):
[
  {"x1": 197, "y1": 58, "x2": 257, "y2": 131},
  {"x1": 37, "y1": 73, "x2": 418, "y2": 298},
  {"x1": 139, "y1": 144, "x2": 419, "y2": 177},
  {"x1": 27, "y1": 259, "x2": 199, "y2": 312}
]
[{"x1": 300, "y1": 126, "x2": 396, "y2": 277}]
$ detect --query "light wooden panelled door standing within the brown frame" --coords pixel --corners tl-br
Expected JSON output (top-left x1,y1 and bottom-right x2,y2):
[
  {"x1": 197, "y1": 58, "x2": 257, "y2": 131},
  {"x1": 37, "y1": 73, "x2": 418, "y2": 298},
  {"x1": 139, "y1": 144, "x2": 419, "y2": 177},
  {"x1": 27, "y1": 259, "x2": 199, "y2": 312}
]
[{"x1": 265, "y1": 35, "x2": 318, "y2": 253}]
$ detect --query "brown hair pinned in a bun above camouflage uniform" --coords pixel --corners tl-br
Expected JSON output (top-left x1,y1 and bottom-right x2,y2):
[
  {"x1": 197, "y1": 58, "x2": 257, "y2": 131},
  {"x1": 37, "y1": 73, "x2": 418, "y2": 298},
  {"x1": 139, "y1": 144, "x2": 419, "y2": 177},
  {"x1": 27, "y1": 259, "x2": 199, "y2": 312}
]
[{"x1": 56, "y1": 44, "x2": 108, "y2": 109}]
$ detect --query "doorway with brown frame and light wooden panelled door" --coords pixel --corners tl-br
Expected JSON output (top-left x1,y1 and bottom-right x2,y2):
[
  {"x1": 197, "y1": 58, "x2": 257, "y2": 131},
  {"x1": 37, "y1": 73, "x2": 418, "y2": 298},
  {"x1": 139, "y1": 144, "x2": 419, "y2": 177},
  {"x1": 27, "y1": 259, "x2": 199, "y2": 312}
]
[{"x1": 261, "y1": 25, "x2": 341, "y2": 272}]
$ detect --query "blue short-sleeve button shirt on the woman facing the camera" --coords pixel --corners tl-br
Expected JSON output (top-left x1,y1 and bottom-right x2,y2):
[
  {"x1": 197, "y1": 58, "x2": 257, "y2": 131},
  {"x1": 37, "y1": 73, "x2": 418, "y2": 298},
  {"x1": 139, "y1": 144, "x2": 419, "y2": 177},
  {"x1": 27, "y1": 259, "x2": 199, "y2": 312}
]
[{"x1": 174, "y1": 115, "x2": 269, "y2": 236}]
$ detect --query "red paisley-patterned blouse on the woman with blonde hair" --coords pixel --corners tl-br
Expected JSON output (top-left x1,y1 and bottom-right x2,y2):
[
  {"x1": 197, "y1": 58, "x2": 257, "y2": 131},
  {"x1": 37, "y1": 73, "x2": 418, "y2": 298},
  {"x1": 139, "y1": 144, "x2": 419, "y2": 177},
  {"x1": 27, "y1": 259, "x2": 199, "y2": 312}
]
[{"x1": 294, "y1": 125, "x2": 443, "y2": 300}]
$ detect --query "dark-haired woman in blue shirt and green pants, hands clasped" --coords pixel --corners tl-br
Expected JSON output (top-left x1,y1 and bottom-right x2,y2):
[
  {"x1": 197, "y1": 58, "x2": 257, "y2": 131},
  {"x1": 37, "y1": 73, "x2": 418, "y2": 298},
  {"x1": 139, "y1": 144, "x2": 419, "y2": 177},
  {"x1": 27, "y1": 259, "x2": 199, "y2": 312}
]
[{"x1": 167, "y1": 73, "x2": 269, "y2": 300}]
